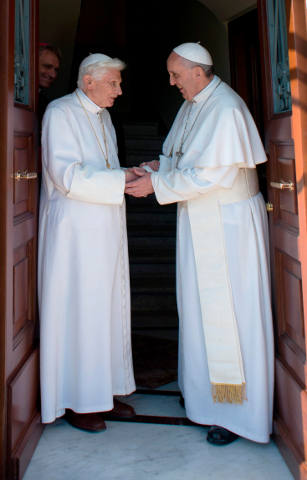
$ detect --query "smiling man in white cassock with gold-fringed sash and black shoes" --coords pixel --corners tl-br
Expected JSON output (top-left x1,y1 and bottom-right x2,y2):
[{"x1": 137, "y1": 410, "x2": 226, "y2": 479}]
[{"x1": 126, "y1": 43, "x2": 274, "y2": 445}]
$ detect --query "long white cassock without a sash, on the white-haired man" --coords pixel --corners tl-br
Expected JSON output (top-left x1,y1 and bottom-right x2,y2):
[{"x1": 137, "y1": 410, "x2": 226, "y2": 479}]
[{"x1": 38, "y1": 90, "x2": 135, "y2": 423}]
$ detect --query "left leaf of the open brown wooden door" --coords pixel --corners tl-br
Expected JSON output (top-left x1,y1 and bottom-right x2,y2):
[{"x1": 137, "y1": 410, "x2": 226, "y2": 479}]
[{"x1": 0, "y1": 0, "x2": 42, "y2": 479}]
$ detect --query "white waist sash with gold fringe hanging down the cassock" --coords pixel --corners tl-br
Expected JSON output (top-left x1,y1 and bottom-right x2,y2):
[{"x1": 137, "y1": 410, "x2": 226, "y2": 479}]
[{"x1": 187, "y1": 168, "x2": 259, "y2": 403}]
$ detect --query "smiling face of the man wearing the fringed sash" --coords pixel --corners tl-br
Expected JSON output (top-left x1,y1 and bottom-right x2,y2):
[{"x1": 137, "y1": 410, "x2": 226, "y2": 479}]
[{"x1": 167, "y1": 52, "x2": 201, "y2": 101}]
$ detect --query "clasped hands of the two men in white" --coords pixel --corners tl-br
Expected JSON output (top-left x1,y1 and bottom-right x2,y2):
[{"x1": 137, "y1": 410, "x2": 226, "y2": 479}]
[{"x1": 125, "y1": 160, "x2": 159, "y2": 197}]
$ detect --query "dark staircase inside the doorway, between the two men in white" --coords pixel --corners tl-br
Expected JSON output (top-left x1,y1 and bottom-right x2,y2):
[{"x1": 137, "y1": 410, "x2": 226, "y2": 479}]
[{"x1": 124, "y1": 122, "x2": 178, "y2": 331}]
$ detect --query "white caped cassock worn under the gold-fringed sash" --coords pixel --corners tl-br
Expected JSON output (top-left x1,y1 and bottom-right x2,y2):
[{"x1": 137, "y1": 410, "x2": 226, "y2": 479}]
[{"x1": 152, "y1": 76, "x2": 274, "y2": 443}]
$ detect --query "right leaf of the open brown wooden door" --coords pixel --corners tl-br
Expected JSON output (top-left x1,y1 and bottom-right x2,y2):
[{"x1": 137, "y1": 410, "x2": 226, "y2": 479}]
[{"x1": 258, "y1": 0, "x2": 307, "y2": 479}]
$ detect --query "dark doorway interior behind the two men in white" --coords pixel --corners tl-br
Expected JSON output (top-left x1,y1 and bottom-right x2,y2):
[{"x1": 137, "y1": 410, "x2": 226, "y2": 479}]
[{"x1": 36, "y1": 0, "x2": 265, "y2": 424}]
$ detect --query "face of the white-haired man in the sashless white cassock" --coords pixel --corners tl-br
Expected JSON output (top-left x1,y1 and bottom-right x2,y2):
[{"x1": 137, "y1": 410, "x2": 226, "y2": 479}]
[{"x1": 83, "y1": 68, "x2": 122, "y2": 108}]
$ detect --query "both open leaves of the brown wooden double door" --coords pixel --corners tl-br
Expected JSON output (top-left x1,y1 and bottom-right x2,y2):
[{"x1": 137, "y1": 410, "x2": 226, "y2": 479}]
[{"x1": 0, "y1": 0, "x2": 307, "y2": 480}]
